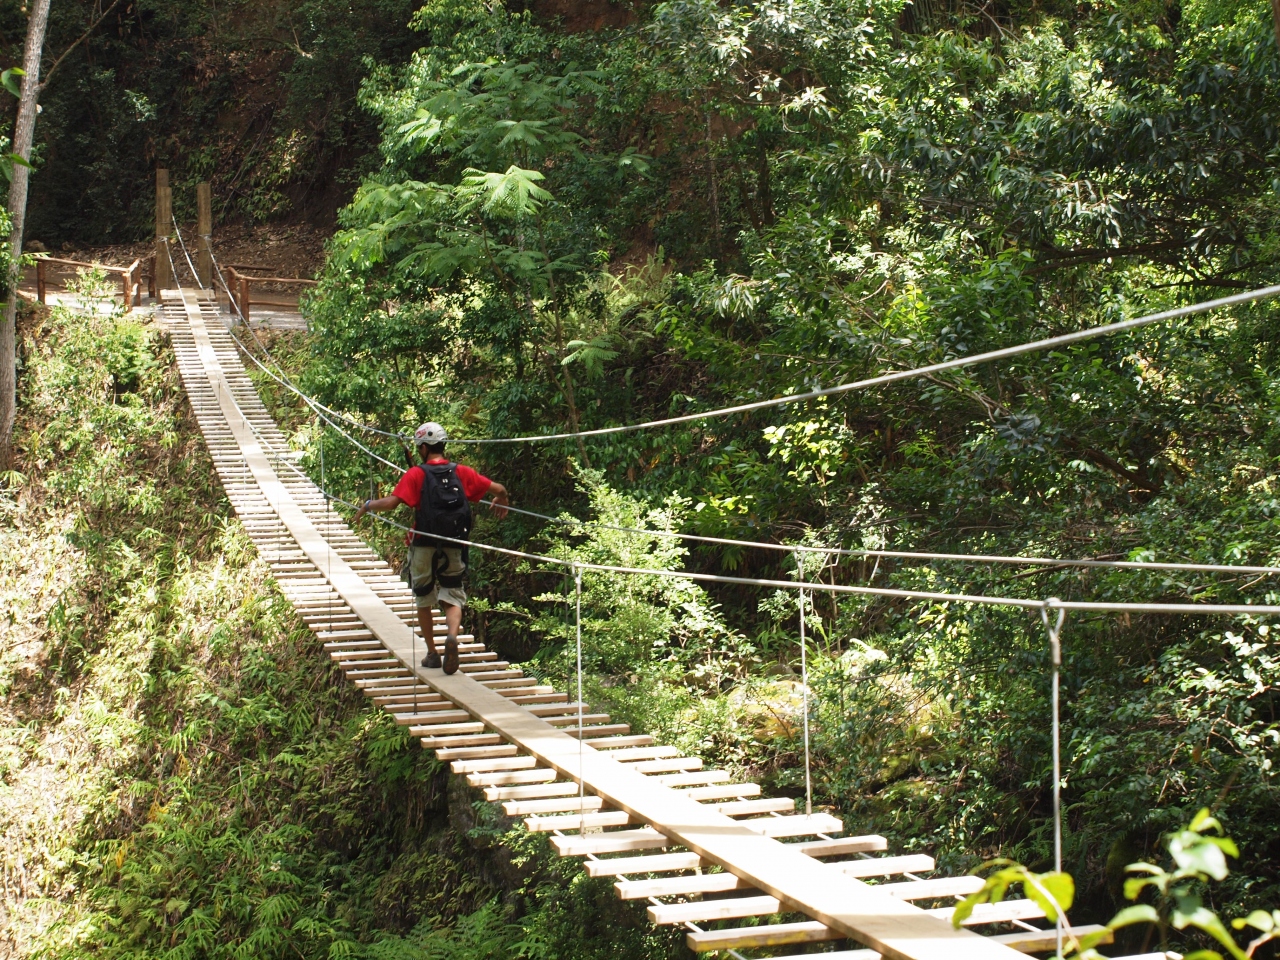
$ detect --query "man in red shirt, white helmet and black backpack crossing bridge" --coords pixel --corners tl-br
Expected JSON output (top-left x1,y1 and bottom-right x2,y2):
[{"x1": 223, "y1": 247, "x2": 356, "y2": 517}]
[{"x1": 351, "y1": 422, "x2": 508, "y2": 673}]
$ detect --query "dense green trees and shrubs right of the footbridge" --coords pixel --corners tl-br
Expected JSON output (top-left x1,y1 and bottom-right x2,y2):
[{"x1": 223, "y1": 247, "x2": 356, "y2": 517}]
[{"x1": 287, "y1": 0, "x2": 1280, "y2": 931}]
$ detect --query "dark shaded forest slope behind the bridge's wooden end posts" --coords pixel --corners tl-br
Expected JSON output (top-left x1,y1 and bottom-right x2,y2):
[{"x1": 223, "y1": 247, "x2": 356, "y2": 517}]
[{"x1": 0, "y1": 0, "x2": 417, "y2": 241}]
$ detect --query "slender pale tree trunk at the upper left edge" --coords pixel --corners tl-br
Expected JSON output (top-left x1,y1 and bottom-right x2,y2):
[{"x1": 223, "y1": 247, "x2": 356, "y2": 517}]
[{"x1": 0, "y1": 0, "x2": 50, "y2": 470}]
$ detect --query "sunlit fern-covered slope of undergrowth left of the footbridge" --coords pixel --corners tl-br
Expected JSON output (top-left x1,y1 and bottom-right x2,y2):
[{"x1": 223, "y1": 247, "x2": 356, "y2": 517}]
[{"x1": 0, "y1": 310, "x2": 680, "y2": 959}]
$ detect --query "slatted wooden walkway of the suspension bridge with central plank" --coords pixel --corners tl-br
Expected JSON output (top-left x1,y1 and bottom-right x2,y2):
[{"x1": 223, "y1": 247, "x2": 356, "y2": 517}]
[{"x1": 160, "y1": 291, "x2": 1121, "y2": 960}]
